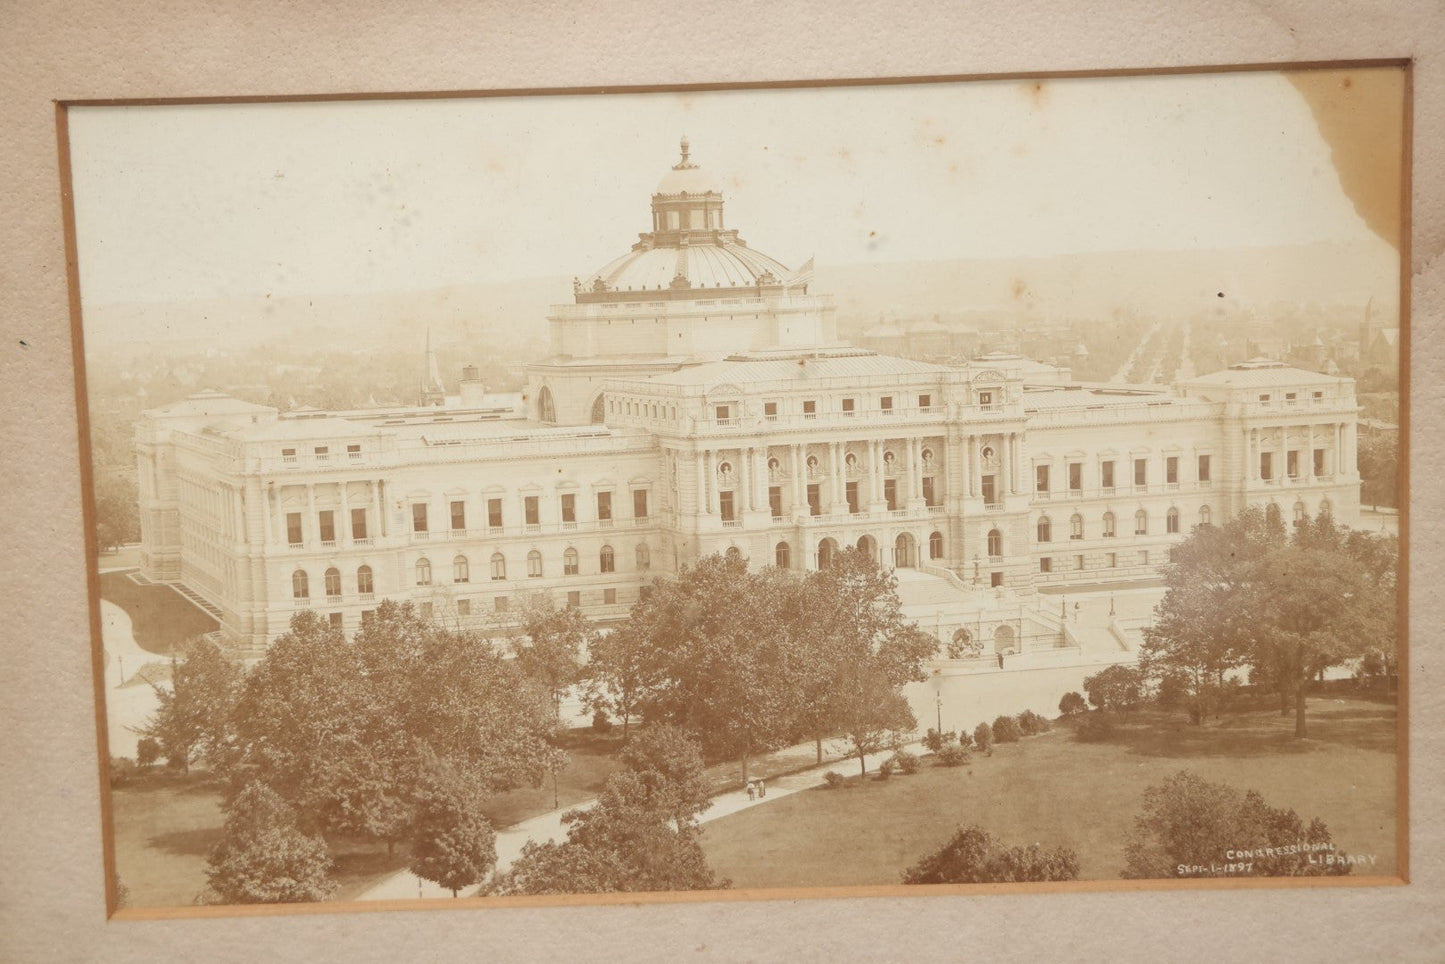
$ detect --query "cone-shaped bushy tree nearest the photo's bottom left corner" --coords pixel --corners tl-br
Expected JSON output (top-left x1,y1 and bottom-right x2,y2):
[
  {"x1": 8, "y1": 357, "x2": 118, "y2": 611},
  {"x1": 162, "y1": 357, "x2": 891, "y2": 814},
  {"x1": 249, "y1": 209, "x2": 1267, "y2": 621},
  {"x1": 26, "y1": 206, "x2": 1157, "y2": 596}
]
[{"x1": 205, "y1": 783, "x2": 335, "y2": 903}]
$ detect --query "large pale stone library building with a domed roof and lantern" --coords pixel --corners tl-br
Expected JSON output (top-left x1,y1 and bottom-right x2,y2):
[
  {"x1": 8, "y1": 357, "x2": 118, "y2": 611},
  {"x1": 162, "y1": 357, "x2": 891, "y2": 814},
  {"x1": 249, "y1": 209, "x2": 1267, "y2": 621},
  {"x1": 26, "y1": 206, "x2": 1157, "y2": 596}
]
[{"x1": 137, "y1": 142, "x2": 1358, "y2": 649}]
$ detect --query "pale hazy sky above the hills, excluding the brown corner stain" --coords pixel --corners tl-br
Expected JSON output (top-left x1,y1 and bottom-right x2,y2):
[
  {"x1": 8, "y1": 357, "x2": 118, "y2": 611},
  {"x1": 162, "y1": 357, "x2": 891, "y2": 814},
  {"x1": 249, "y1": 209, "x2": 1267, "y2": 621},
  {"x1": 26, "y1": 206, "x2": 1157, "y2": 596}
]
[{"x1": 71, "y1": 74, "x2": 1398, "y2": 313}]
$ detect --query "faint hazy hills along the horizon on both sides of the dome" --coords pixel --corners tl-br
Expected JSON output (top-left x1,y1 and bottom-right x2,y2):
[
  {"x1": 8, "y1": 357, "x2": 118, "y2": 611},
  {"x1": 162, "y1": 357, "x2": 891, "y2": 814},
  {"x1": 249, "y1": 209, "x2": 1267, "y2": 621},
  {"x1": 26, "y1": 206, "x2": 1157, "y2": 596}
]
[{"x1": 85, "y1": 241, "x2": 1399, "y2": 358}]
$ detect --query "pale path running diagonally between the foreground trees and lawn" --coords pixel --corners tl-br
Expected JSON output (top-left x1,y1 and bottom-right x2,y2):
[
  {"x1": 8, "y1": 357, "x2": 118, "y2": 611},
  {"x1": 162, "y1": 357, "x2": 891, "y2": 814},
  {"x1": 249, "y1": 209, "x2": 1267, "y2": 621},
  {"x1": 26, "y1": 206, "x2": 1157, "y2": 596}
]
[{"x1": 357, "y1": 744, "x2": 922, "y2": 900}]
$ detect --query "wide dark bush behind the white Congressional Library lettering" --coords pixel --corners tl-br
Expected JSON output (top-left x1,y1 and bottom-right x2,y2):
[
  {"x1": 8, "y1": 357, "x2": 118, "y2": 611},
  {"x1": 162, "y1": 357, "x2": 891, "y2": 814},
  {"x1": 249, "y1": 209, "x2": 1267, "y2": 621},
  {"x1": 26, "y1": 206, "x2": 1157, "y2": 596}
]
[{"x1": 1123, "y1": 770, "x2": 1350, "y2": 879}]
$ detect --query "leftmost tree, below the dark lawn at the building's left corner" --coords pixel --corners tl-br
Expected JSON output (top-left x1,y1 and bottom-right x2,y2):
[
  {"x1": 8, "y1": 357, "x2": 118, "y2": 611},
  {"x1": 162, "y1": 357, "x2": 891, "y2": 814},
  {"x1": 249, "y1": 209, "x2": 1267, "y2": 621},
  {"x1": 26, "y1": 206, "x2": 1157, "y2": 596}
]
[{"x1": 139, "y1": 637, "x2": 241, "y2": 772}]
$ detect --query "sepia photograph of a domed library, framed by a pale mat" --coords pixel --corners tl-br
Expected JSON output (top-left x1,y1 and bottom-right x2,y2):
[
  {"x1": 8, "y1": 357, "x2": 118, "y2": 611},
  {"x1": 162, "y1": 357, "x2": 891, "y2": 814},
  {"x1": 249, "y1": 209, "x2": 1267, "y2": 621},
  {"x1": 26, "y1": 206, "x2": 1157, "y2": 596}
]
[{"x1": 62, "y1": 64, "x2": 1409, "y2": 918}]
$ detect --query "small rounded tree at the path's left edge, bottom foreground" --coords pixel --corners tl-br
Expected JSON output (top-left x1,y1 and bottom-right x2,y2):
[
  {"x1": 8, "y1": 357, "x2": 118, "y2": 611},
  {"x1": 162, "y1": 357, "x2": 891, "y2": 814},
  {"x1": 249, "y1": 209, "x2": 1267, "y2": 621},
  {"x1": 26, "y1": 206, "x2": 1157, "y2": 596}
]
[{"x1": 410, "y1": 760, "x2": 497, "y2": 898}]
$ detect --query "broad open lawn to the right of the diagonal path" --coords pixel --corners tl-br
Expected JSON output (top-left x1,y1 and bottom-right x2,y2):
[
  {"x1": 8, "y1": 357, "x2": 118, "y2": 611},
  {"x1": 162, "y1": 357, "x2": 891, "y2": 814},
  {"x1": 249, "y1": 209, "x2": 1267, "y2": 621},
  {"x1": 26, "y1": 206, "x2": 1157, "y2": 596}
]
[{"x1": 702, "y1": 697, "x2": 1396, "y2": 887}]
